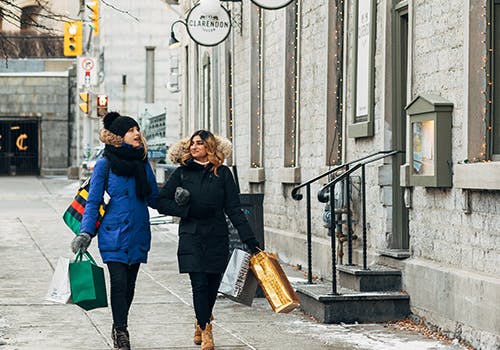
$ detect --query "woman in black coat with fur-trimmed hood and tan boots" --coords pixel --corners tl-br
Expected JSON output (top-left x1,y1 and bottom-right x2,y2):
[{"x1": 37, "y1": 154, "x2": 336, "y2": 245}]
[{"x1": 157, "y1": 130, "x2": 259, "y2": 350}]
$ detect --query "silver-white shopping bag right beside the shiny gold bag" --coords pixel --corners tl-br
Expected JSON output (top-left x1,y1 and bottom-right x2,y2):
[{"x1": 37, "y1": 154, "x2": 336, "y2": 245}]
[{"x1": 219, "y1": 249, "x2": 258, "y2": 306}]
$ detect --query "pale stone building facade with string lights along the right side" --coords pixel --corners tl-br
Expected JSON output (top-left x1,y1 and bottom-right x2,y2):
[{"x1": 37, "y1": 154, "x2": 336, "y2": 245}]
[{"x1": 179, "y1": 0, "x2": 500, "y2": 349}]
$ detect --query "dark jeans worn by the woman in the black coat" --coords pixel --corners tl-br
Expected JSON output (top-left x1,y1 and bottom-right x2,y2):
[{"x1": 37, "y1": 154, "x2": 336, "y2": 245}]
[{"x1": 189, "y1": 272, "x2": 222, "y2": 329}]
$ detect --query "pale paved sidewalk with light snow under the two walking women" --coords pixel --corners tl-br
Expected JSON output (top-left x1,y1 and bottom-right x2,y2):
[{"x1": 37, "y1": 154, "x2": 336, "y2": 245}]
[{"x1": 0, "y1": 177, "x2": 463, "y2": 350}]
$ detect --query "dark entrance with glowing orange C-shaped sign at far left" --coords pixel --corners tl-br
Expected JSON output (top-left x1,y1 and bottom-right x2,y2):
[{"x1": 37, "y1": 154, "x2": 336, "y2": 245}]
[{"x1": 0, "y1": 118, "x2": 40, "y2": 175}]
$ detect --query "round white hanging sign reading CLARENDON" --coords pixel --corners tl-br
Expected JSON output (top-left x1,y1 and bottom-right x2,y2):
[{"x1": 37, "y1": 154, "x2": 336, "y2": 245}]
[{"x1": 186, "y1": 5, "x2": 231, "y2": 46}]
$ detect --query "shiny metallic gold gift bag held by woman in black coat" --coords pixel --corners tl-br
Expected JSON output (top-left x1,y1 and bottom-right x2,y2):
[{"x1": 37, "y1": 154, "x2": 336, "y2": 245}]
[{"x1": 250, "y1": 251, "x2": 300, "y2": 313}]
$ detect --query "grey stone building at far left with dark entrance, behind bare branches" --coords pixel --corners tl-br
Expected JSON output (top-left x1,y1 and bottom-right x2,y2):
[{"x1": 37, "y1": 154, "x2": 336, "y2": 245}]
[{"x1": 0, "y1": 1, "x2": 78, "y2": 175}]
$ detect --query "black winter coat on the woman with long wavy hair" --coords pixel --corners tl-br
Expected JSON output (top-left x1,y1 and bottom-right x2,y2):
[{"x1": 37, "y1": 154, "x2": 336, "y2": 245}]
[{"x1": 157, "y1": 160, "x2": 254, "y2": 273}]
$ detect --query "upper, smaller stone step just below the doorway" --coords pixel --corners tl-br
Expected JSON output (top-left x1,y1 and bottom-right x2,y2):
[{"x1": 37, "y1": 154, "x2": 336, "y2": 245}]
[{"x1": 337, "y1": 265, "x2": 401, "y2": 292}]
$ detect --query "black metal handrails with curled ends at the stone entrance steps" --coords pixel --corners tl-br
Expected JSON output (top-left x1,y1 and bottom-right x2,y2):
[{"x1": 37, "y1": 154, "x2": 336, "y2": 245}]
[{"x1": 291, "y1": 150, "x2": 404, "y2": 294}]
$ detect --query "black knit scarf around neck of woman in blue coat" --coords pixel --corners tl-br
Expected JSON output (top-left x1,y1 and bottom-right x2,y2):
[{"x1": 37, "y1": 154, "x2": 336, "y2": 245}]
[{"x1": 104, "y1": 145, "x2": 151, "y2": 200}]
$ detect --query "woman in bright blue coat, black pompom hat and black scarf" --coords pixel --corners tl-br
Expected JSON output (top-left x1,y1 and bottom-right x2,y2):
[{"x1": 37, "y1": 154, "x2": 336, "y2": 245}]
[{"x1": 71, "y1": 112, "x2": 158, "y2": 350}]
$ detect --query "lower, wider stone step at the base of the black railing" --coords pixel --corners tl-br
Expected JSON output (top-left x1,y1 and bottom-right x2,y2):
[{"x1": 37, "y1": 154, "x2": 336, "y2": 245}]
[{"x1": 296, "y1": 284, "x2": 410, "y2": 323}]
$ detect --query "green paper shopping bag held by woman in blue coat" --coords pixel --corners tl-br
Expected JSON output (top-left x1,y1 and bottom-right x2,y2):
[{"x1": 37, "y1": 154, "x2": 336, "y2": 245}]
[{"x1": 69, "y1": 251, "x2": 108, "y2": 310}]
